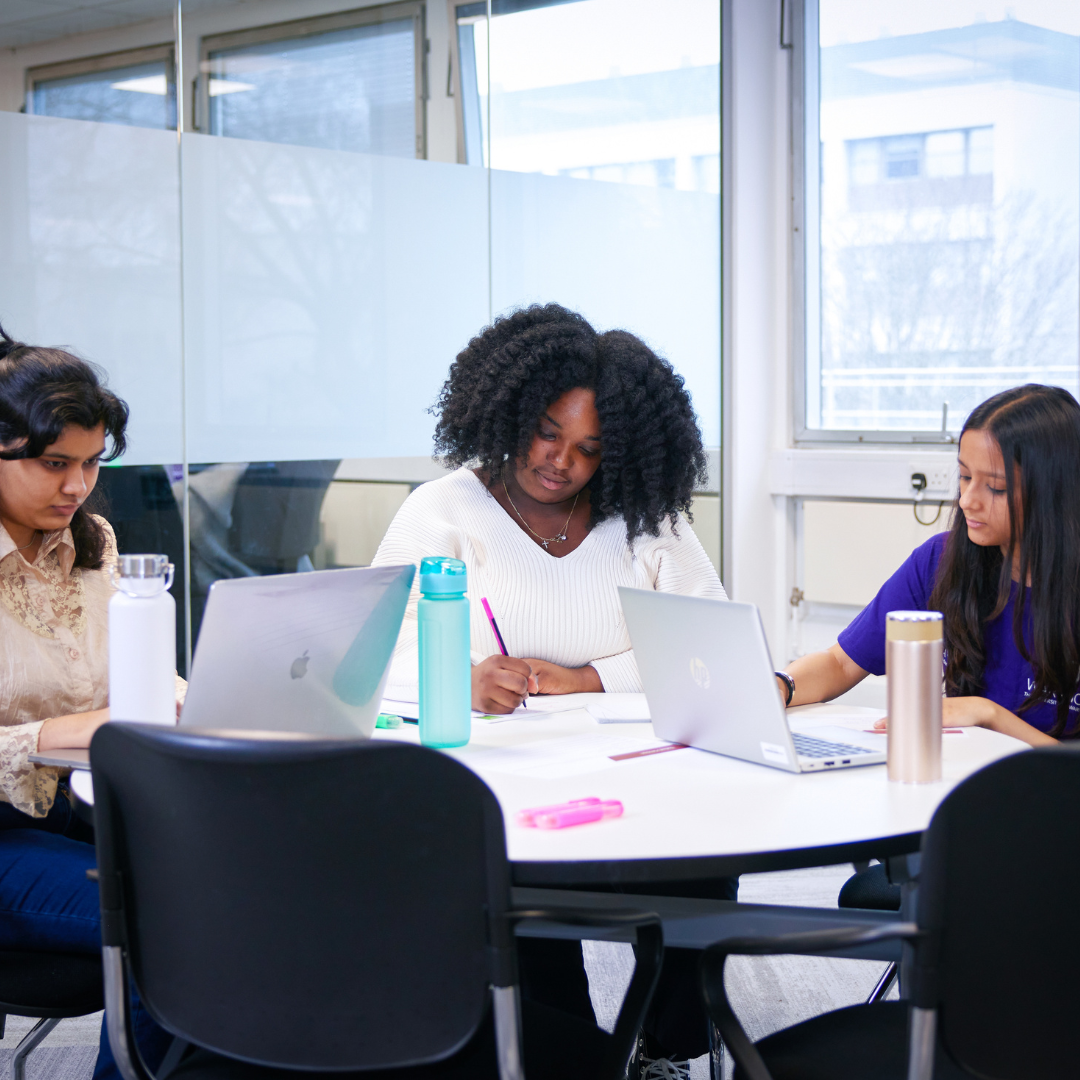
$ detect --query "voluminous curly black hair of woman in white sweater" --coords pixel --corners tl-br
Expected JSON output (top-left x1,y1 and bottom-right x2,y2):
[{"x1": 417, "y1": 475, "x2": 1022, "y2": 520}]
[{"x1": 432, "y1": 303, "x2": 707, "y2": 543}]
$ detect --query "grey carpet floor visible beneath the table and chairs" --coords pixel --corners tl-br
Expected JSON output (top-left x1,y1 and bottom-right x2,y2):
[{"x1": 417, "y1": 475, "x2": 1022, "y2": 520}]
[{"x1": 0, "y1": 864, "x2": 895, "y2": 1080}]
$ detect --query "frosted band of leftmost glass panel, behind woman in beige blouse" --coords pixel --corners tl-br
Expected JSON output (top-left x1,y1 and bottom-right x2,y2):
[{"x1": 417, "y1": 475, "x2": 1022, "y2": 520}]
[{"x1": 0, "y1": 112, "x2": 183, "y2": 464}]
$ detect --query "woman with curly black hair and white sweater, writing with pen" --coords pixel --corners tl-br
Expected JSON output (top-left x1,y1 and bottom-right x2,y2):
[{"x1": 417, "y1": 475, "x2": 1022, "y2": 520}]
[{"x1": 375, "y1": 303, "x2": 737, "y2": 1076}]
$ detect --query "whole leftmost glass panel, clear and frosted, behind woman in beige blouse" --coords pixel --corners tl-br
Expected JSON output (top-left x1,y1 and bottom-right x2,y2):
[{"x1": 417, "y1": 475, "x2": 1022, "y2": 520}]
[{"x1": 0, "y1": 0, "x2": 186, "y2": 674}]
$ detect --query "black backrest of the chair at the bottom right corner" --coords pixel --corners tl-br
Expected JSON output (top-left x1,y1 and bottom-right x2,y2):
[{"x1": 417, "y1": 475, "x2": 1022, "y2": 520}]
[{"x1": 914, "y1": 745, "x2": 1080, "y2": 1080}]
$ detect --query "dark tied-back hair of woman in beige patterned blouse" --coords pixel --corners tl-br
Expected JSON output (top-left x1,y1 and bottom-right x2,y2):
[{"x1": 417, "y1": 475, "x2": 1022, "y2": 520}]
[{"x1": 0, "y1": 326, "x2": 127, "y2": 570}]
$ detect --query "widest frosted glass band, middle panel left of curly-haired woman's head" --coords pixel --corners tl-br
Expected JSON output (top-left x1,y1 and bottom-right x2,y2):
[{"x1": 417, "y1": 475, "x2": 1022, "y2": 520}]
[{"x1": 184, "y1": 135, "x2": 488, "y2": 462}]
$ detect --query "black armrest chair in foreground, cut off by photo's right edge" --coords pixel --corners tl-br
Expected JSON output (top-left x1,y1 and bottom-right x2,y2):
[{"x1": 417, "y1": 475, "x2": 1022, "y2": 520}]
[{"x1": 701, "y1": 746, "x2": 1080, "y2": 1080}]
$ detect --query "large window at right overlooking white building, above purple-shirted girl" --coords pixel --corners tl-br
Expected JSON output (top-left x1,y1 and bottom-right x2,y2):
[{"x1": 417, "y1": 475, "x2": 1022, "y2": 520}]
[{"x1": 796, "y1": 0, "x2": 1080, "y2": 441}]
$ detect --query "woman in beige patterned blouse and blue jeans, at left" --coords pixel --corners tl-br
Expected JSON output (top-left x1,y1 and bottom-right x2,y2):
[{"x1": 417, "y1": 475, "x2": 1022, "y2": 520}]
[{"x1": 0, "y1": 327, "x2": 167, "y2": 1080}]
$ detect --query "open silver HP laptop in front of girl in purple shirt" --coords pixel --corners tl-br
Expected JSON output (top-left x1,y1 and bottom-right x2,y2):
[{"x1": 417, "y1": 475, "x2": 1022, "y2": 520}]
[{"x1": 619, "y1": 589, "x2": 886, "y2": 772}]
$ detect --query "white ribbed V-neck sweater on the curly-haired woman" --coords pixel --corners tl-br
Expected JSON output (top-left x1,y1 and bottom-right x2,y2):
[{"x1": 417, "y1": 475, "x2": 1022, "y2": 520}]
[{"x1": 373, "y1": 469, "x2": 727, "y2": 700}]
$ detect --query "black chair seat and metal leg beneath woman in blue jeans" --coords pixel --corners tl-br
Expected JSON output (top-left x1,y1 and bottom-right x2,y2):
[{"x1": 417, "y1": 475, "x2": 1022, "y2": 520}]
[{"x1": 0, "y1": 950, "x2": 105, "y2": 1080}]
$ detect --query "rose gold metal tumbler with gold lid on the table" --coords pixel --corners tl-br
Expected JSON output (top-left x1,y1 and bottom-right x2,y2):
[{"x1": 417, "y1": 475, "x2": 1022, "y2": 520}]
[{"x1": 885, "y1": 611, "x2": 944, "y2": 784}]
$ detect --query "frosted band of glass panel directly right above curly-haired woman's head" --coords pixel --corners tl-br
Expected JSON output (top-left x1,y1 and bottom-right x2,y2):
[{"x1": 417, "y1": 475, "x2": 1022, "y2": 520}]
[{"x1": 494, "y1": 170, "x2": 720, "y2": 446}]
